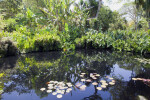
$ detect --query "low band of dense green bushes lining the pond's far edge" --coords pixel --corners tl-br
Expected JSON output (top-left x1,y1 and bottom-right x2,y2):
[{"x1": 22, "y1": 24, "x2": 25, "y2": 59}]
[{"x1": 0, "y1": 30, "x2": 150, "y2": 55}]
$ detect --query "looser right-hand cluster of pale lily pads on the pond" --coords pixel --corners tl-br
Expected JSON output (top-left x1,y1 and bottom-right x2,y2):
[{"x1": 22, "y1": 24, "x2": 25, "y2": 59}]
[{"x1": 76, "y1": 73, "x2": 115, "y2": 90}]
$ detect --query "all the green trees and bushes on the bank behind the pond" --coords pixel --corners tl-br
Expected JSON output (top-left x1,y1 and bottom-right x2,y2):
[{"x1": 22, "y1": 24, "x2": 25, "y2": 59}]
[{"x1": 0, "y1": 0, "x2": 150, "y2": 56}]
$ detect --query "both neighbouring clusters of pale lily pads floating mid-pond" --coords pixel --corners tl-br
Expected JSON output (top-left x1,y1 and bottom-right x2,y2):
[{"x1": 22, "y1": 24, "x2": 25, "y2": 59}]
[{"x1": 40, "y1": 73, "x2": 115, "y2": 98}]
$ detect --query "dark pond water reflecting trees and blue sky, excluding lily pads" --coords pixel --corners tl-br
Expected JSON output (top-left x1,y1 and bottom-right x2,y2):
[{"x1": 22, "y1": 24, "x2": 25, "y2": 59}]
[{"x1": 0, "y1": 50, "x2": 150, "y2": 100}]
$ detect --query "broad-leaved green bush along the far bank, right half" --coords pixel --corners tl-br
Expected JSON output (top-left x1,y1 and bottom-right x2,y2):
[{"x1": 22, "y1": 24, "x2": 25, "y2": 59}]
[{"x1": 75, "y1": 30, "x2": 150, "y2": 53}]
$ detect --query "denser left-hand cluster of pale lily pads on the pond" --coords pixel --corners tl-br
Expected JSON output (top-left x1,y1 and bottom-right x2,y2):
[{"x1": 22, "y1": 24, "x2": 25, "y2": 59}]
[{"x1": 40, "y1": 81, "x2": 73, "y2": 98}]
